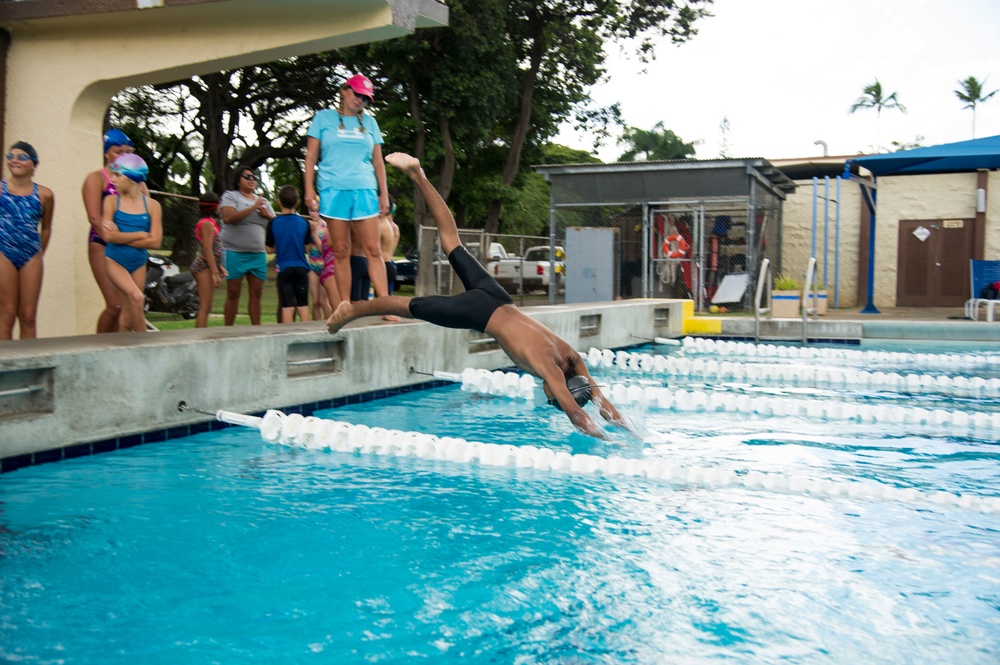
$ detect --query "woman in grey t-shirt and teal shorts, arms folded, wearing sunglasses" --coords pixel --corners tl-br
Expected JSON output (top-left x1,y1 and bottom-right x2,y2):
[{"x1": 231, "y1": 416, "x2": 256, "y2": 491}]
[{"x1": 219, "y1": 166, "x2": 274, "y2": 326}]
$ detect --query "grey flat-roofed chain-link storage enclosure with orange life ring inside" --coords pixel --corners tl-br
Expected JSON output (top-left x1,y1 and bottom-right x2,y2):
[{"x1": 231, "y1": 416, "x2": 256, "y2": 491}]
[{"x1": 538, "y1": 159, "x2": 794, "y2": 309}]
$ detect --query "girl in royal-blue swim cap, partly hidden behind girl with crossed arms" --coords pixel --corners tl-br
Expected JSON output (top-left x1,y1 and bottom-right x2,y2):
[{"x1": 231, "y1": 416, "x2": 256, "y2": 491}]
[{"x1": 83, "y1": 129, "x2": 149, "y2": 333}]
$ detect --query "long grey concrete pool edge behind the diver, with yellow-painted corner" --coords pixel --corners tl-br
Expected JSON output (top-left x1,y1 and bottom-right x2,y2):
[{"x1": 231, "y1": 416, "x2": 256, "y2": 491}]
[{"x1": 0, "y1": 300, "x2": 1000, "y2": 472}]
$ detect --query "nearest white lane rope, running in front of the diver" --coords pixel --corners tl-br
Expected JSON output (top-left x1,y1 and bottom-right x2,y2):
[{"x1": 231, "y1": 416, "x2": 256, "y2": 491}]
[{"x1": 215, "y1": 410, "x2": 1000, "y2": 514}]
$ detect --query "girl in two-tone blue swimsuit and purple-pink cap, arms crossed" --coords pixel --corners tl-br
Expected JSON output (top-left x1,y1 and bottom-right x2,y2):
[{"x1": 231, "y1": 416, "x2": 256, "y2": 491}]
[{"x1": 102, "y1": 153, "x2": 163, "y2": 332}]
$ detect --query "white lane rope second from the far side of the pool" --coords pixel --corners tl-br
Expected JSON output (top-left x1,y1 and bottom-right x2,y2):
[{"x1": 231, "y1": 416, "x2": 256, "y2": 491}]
[{"x1": 584, "y1": 348, "x2": 1000, "y2": 397}]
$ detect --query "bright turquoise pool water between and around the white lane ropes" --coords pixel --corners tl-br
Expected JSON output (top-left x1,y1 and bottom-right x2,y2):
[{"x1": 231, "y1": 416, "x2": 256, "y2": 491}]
[{"x1": 0, "y1": 344, "x2": 1000, "y2": 663}]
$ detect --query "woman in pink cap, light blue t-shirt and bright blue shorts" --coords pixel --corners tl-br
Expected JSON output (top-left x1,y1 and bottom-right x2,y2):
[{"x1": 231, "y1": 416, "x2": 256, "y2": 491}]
[{"x1": 305, "y1": 74, "x2": 389, "y2": 312}]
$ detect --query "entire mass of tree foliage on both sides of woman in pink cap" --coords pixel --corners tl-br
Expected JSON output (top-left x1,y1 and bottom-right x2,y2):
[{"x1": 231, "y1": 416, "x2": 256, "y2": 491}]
[{"x1": 110, "y1": 0, "x2": 711, "y2": 236}]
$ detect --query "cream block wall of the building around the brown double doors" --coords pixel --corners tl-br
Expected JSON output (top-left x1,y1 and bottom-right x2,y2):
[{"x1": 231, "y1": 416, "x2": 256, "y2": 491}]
[{"x1": 782, "y1": 172, "x2": 1000, "y2": 307}]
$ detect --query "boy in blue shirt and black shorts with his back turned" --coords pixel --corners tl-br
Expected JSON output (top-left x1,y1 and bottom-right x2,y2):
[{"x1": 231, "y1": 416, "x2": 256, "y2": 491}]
[{"x1": 264, "y1": 185, "x2": 312, "y2": 323}]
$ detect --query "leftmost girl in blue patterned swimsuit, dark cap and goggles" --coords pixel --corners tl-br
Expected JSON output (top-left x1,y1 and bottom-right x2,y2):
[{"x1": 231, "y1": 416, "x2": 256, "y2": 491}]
[{"x1": 0, "y1": 141, "x2": 55, "y2": 339}]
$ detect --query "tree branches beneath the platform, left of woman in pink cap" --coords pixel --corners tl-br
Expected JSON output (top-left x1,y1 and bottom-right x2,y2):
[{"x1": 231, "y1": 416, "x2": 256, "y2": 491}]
[{"x1": 108, "y1": 53, "x2": 345, "y2": 195}]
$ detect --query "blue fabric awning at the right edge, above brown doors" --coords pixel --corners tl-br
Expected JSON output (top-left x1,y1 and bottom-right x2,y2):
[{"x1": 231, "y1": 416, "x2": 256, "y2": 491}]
[{"x1": 845, "y1": 136, "x2": 1000, "y2": 176}]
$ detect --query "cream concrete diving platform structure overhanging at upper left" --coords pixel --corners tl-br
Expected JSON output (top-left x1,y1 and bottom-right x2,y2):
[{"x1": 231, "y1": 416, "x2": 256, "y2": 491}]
[{"x1": 2, "y1": 0, "x2": 448, "y2": 337}]
